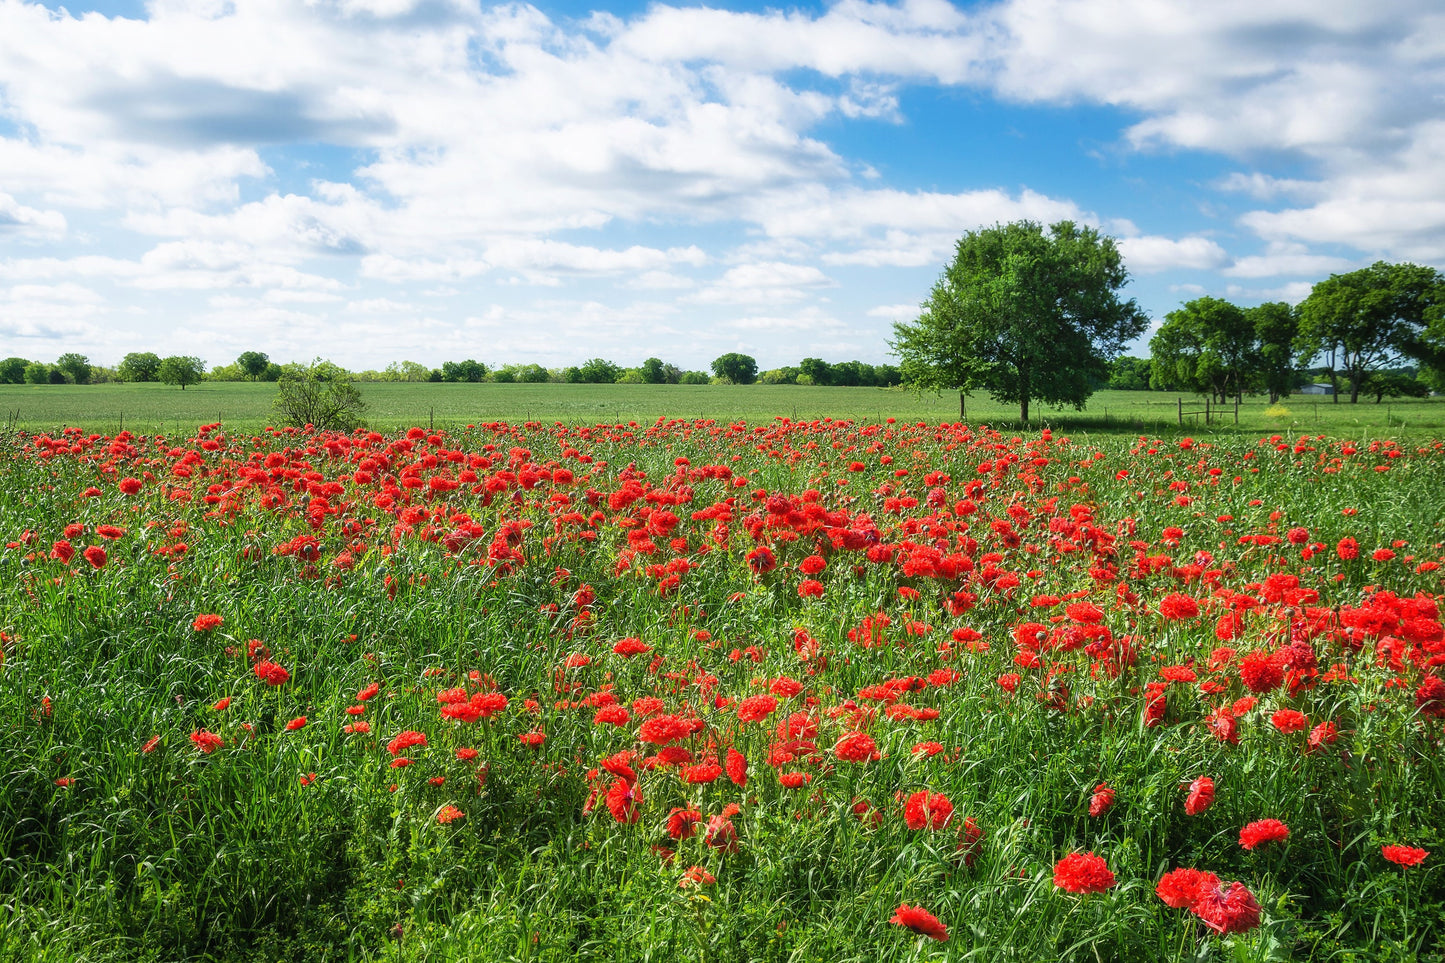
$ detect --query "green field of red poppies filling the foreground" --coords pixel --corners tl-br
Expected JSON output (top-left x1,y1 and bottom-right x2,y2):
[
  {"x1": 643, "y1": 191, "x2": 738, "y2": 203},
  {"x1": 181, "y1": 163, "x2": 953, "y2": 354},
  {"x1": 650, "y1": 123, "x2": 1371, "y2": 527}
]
[{"x1": 0, "y1": 419, "x2": 1445, "y2": 962}]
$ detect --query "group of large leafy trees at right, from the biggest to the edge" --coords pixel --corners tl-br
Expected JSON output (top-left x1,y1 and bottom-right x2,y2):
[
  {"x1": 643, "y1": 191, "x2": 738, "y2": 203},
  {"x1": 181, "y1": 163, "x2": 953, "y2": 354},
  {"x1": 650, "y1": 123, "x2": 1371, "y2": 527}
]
[{"x1": 892, "y1": 221, "x2": 1445, "y2": 421}]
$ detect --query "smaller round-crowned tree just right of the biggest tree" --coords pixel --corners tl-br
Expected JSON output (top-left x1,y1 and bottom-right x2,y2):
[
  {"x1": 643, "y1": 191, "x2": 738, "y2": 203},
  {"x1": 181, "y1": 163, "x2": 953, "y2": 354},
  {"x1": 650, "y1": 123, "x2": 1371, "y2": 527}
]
[{"x1": 1149, "y1": 296, "x2": 1259, "y2": 403}]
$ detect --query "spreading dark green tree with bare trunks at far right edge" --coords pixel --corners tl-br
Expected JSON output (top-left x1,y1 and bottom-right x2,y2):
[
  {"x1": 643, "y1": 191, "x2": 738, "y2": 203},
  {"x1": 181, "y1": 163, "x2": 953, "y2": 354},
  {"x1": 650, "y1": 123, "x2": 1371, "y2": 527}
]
[{"x1": 1296, "y1": 260, "x2": 1445, "y2": 405}]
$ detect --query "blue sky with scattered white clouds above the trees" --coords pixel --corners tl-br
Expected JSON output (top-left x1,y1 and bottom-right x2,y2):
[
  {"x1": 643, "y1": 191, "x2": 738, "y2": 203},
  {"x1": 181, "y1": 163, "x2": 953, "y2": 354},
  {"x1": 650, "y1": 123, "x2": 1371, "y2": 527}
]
[{"x1": 0, "y1": 0, "x2": 1445, "y2": 370}]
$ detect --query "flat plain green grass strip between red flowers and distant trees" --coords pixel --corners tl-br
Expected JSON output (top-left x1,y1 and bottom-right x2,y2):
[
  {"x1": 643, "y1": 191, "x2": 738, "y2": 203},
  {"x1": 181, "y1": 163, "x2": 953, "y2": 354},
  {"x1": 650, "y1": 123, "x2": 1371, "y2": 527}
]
[{"x1": 0, "y1": 382, "x2": 1445, "y2": 437}]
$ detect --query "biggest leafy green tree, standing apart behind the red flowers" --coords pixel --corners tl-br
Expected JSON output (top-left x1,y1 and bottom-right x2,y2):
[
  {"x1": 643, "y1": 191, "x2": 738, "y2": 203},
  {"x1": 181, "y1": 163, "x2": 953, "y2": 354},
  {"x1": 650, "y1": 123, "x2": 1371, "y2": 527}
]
[{"x1": 892, "y1": 221, "x2": 1149, "y2": 422}]
